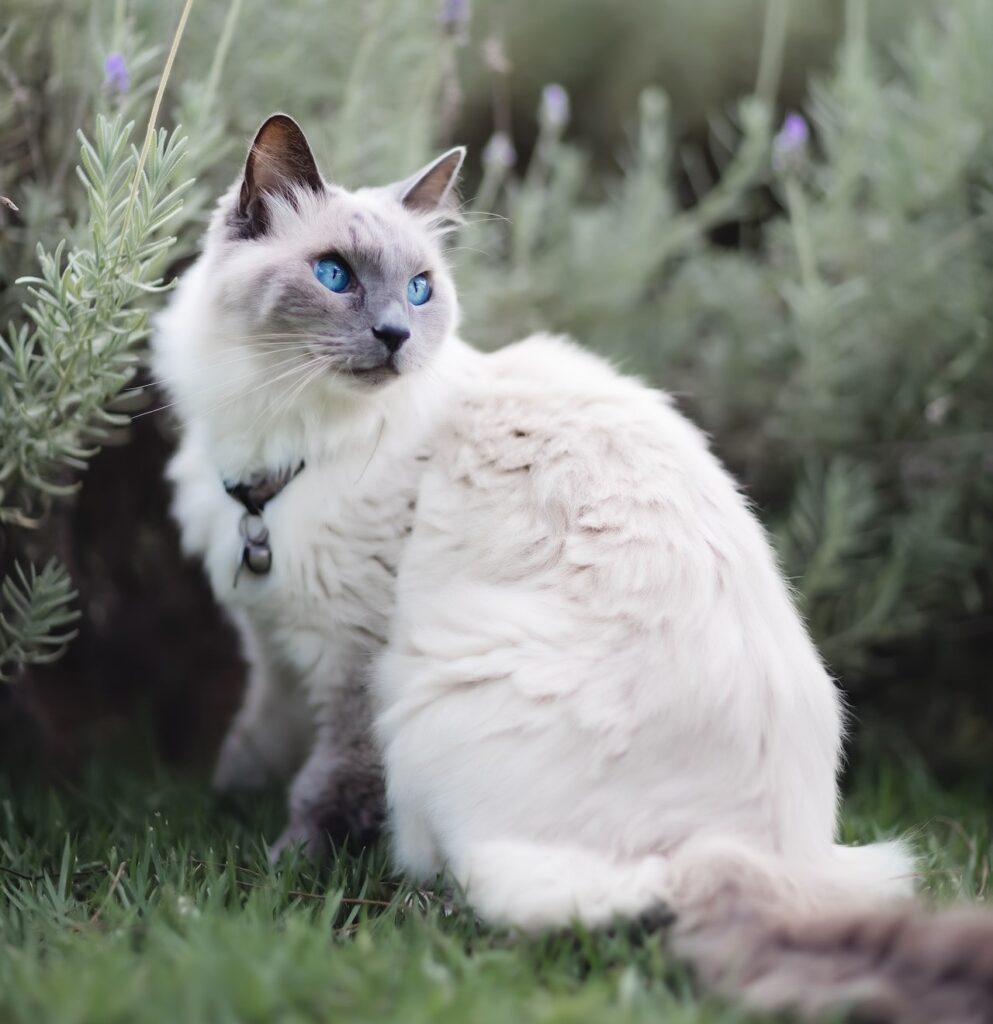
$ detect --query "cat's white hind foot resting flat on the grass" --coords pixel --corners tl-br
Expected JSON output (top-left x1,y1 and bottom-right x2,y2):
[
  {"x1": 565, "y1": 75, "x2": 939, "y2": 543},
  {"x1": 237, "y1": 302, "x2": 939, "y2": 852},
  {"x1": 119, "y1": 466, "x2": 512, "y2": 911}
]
[{"x1": 449, "y1": 840, "x2": 668, "y2": 932}]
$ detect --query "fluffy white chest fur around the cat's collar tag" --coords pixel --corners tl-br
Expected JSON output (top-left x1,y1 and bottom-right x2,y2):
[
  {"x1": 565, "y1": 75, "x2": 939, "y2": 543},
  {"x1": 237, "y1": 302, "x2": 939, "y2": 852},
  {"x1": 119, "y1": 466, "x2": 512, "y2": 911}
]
[{"x1": 170, "y1": 423, "x2": 425, "y2": 677}]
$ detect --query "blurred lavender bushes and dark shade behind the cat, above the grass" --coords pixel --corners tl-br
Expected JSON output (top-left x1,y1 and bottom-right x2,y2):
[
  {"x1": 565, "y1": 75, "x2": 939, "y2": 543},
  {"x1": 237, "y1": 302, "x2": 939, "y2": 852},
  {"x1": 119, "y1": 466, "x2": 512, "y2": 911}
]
[{"x1": 0, "y1": 0, "x2": 993, "y2": 785}]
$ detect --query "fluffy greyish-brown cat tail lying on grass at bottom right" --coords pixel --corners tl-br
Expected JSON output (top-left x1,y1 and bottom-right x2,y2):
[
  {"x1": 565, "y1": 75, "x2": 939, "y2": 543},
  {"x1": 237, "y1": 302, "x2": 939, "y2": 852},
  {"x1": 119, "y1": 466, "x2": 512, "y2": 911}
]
[{"x1": 671, "y1": 844, "x2": 993, "y2": 1024}]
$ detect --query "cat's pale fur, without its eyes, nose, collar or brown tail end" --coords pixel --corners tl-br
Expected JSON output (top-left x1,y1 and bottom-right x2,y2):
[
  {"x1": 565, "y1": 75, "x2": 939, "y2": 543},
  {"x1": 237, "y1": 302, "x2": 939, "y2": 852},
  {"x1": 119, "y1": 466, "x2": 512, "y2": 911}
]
[{"x1": 157, "y1": 118, "x2": 979, "y2": 1021}]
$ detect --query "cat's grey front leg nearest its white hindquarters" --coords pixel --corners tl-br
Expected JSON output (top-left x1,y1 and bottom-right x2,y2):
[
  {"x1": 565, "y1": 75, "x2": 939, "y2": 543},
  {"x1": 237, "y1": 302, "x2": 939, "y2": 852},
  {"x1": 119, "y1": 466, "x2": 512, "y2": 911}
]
[{"x1": 269, "y1": 681, "x2": 385, "y2": 862}]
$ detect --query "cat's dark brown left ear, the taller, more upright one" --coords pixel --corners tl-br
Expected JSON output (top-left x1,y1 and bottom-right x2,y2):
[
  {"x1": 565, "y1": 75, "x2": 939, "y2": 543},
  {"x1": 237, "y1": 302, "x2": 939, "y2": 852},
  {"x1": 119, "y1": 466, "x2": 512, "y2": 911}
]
[{"x1": 238, "y1": 114, "x2": 325, "y2": 238}]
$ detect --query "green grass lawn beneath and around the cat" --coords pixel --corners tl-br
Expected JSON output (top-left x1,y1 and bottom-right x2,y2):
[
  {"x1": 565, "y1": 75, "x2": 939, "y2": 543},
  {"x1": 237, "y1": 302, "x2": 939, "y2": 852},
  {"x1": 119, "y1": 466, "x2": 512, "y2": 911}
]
[{"x1": 0, "y1": 767, "x2": 993, "y2": 1024}]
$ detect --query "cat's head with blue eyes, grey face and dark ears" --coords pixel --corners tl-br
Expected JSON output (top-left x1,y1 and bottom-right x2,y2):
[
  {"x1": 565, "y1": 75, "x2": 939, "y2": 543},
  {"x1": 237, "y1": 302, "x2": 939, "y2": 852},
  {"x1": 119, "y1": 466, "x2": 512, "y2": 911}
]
[{"x1": 206, "y1": 114, "x2": 465, "y2": 390}]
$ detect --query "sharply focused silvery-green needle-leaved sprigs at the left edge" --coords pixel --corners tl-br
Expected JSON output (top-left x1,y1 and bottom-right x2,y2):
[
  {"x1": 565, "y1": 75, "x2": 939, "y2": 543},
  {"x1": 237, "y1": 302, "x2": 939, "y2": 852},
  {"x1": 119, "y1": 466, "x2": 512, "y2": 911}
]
[{"x1": 0, "y1": 117, "x2": 187, "y2": 679}]
